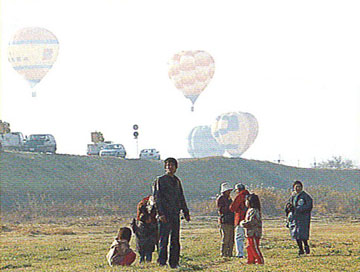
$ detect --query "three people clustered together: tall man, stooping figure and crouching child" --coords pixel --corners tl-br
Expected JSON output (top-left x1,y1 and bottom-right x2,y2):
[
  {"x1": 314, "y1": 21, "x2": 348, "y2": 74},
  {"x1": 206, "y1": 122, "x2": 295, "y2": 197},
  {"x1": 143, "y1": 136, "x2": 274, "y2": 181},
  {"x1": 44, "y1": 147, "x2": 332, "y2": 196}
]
[{"x1": 107, "y1": 158, "x2": 190, "y2": 268}]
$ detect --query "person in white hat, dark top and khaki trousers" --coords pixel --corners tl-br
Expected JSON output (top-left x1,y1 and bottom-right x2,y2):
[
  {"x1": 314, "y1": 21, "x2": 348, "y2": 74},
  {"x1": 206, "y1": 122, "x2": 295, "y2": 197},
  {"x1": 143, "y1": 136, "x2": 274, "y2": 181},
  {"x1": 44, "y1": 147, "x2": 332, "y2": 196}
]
[{"x1": 216, "y1": 182, "x2": 234, "y2": 257}]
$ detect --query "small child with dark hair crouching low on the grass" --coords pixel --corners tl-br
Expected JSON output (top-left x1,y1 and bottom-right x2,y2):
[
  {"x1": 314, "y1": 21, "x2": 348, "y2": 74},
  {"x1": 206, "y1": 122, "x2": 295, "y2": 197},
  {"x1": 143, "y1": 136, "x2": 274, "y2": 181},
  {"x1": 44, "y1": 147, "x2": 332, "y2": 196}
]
[{"x1": 106, "y1": 227, "x2": 136, "y2": 266}]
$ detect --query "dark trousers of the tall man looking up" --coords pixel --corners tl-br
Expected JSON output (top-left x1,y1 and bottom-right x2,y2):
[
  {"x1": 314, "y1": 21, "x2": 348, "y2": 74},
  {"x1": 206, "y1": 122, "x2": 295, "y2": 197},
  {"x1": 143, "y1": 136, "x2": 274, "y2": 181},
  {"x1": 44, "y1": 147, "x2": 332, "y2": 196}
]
[{"x1": 158, "y1": 215, "x2": 180, "y2": 266}]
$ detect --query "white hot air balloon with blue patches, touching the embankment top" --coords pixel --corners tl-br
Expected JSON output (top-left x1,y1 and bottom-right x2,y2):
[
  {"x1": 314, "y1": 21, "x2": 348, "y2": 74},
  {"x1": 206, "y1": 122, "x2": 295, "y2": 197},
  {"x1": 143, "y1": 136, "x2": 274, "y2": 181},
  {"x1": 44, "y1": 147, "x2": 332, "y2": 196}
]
[{"x1": 211, "y1": 112, "x2": 259, "y2": 157}]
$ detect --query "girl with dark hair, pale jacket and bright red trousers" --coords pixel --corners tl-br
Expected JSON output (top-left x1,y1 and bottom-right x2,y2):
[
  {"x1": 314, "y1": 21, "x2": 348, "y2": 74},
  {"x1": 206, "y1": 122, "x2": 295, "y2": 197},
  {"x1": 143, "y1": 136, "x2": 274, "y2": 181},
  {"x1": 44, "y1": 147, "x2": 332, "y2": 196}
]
[{"x1": 240, "y1": 194, "x2": 264, "y2": 264}]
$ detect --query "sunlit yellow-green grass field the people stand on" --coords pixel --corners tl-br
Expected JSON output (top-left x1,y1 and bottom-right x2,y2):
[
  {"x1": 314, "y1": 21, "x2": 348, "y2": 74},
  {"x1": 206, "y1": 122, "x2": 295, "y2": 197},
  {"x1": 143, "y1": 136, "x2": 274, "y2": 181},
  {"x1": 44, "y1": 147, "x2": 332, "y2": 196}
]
[{"x1": 0, "y1": 217, "x2": 360, "y2": 271}]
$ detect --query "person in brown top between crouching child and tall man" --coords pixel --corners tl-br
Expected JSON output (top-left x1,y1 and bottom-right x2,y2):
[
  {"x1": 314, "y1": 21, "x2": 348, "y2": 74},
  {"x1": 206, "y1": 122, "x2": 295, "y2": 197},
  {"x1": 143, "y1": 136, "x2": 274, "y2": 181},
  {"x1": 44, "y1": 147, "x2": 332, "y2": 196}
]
[{"x1": 131, "y1": 196, "x2": 158, "y2": 263}]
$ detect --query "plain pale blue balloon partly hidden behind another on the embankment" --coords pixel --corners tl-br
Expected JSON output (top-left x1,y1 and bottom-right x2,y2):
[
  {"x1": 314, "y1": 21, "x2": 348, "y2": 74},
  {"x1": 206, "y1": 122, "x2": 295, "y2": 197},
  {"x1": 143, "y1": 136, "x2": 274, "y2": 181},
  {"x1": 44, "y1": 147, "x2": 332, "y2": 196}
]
[{"x1": 188, "y1": 126, "x2": 225, "y2": 158}]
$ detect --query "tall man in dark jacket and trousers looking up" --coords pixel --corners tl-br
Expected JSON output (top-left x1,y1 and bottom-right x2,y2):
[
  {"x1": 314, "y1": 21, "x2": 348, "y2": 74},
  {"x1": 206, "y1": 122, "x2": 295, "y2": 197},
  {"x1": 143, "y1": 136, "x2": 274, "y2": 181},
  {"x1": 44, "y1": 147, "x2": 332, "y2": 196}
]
[{"x1": 154, "y1": 158, "x2": 190, "y2": 268}]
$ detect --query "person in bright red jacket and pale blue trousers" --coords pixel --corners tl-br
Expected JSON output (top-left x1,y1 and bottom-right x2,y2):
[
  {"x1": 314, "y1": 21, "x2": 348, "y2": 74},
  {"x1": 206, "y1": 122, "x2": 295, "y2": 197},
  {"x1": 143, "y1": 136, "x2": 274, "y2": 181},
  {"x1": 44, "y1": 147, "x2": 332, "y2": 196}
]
[{"x1": 230, "y1": 183, "x2": 249, "y2": 258}]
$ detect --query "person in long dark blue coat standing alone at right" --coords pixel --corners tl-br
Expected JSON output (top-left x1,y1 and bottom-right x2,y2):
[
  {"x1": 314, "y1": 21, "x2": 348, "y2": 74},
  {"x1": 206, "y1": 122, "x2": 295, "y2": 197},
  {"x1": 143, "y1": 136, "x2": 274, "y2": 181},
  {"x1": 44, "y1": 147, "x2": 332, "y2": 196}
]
[{"x1": 285, "y1": 180, "x2": 313, "y2": 255}]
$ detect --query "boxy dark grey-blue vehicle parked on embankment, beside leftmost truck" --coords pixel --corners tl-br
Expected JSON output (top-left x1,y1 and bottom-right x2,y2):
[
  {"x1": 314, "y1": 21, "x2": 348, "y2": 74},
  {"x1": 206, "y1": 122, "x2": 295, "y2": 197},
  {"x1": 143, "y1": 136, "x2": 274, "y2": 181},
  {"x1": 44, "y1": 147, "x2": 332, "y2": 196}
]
[{"x1": 23, "y1": 134, "x2": 56, "y2": 153}]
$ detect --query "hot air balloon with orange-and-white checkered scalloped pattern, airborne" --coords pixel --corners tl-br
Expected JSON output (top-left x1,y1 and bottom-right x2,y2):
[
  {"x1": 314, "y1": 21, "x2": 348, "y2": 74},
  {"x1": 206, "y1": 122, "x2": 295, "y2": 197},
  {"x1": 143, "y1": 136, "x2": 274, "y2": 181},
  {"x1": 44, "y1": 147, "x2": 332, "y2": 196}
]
[{"x1": 169, "y1": 50, "x2": 215, "y2": 111}]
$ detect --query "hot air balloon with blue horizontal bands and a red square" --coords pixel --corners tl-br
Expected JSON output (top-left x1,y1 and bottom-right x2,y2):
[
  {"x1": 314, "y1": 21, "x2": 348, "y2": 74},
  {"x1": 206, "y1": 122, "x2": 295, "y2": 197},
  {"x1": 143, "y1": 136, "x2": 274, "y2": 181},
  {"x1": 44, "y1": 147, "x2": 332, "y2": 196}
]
[{"x1": 8, "y1": 27, "x2": 59, "y2": 97}]
